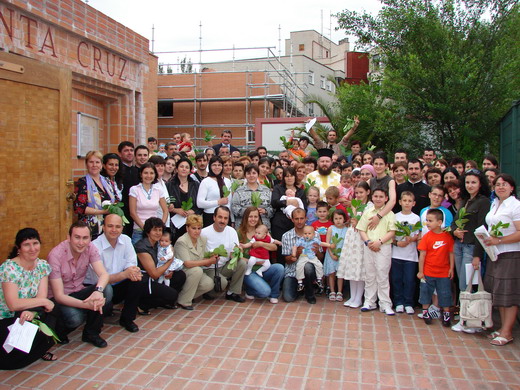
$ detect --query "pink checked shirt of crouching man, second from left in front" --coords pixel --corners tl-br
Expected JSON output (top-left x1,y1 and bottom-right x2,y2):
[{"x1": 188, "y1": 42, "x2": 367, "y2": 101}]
[{"x1": 47, "y1": 240, "x2": 101, "y2": 298}]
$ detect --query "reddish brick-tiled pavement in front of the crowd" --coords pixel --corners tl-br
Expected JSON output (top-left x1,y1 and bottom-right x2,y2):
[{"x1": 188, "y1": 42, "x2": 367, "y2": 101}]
[{"x1": 0, "y1": 297, "x2": 520, "y2": 390}]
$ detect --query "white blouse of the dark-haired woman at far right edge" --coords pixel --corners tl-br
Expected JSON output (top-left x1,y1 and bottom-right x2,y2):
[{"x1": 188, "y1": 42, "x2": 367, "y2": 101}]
[{"x1": 486, "y1": 196, "x2": 520, "y2": 254}]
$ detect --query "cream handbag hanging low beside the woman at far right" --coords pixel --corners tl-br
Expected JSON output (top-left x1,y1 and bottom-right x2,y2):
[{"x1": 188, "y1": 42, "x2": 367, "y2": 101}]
[{"x1": 460, "y1": 269, "x2": 493, "y2": 328}]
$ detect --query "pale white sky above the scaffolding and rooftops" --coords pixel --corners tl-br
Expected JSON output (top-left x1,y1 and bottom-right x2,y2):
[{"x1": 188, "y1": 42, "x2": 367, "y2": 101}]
[{"x1": 86, "y1": 0, "x2": 381, "y2": 63}]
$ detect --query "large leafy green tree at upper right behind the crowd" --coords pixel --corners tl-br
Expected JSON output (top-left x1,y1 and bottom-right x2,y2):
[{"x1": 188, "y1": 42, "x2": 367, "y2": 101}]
[{"x1": 337, "y1": 0, "x2": 520, "y2": 159}]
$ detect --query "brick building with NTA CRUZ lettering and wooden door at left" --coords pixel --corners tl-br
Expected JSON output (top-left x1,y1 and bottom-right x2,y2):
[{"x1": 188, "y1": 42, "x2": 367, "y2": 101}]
[{"x1": 0, "y1": 0, "x2": 157, "y2": 256}]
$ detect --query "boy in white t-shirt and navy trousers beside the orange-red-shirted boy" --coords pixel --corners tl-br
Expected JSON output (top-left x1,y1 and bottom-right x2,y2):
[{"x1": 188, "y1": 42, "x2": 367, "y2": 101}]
[{"x1": 390, "y1": 191, "x2": 421, "y2": 314}]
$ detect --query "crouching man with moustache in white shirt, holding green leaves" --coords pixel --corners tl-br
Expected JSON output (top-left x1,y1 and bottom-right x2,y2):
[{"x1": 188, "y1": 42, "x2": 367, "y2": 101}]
[{"x1": 201, "y1": 206, "x2": 247, "y2": 303}]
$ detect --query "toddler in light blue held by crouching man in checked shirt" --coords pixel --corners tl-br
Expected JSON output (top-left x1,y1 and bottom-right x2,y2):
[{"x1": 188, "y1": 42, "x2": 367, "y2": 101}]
[{"x1": 292, "y1": 226, "x2": 334, "y2": 291}]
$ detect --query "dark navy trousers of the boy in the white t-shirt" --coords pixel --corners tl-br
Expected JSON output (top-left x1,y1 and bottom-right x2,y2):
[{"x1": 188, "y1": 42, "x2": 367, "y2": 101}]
[{"x1": 390, "y1": 259, "x2": 417, "y2": 307}]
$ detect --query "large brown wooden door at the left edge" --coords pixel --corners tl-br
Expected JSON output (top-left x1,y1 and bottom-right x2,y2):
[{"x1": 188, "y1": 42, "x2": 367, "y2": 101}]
[{"x1": 0, "y1": 52, "x2": 73, "y2": 260}]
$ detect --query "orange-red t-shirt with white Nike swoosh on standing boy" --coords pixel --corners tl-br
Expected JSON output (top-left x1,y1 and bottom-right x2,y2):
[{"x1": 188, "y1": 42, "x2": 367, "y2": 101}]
[{"x1": 417, "y1": 231, "x2": 454, "y2": 278}]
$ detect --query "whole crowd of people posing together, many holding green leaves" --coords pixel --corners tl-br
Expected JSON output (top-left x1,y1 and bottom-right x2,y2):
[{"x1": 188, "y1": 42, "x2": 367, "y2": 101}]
[{"x1": 0, "y1": 126, "x2": 520, "y2": 369}]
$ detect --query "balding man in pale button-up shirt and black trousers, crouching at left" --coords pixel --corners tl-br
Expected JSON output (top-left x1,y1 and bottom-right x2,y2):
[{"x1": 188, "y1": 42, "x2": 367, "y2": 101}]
[{"x1": 84, "y1": 214, "x2": 146, "y2": 333}]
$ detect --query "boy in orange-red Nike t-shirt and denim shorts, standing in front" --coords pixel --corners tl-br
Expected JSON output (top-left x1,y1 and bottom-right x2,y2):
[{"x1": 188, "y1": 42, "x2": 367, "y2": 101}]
[{"x1": 417, "y1": 208, "x2": 455, "y2": 327}]
